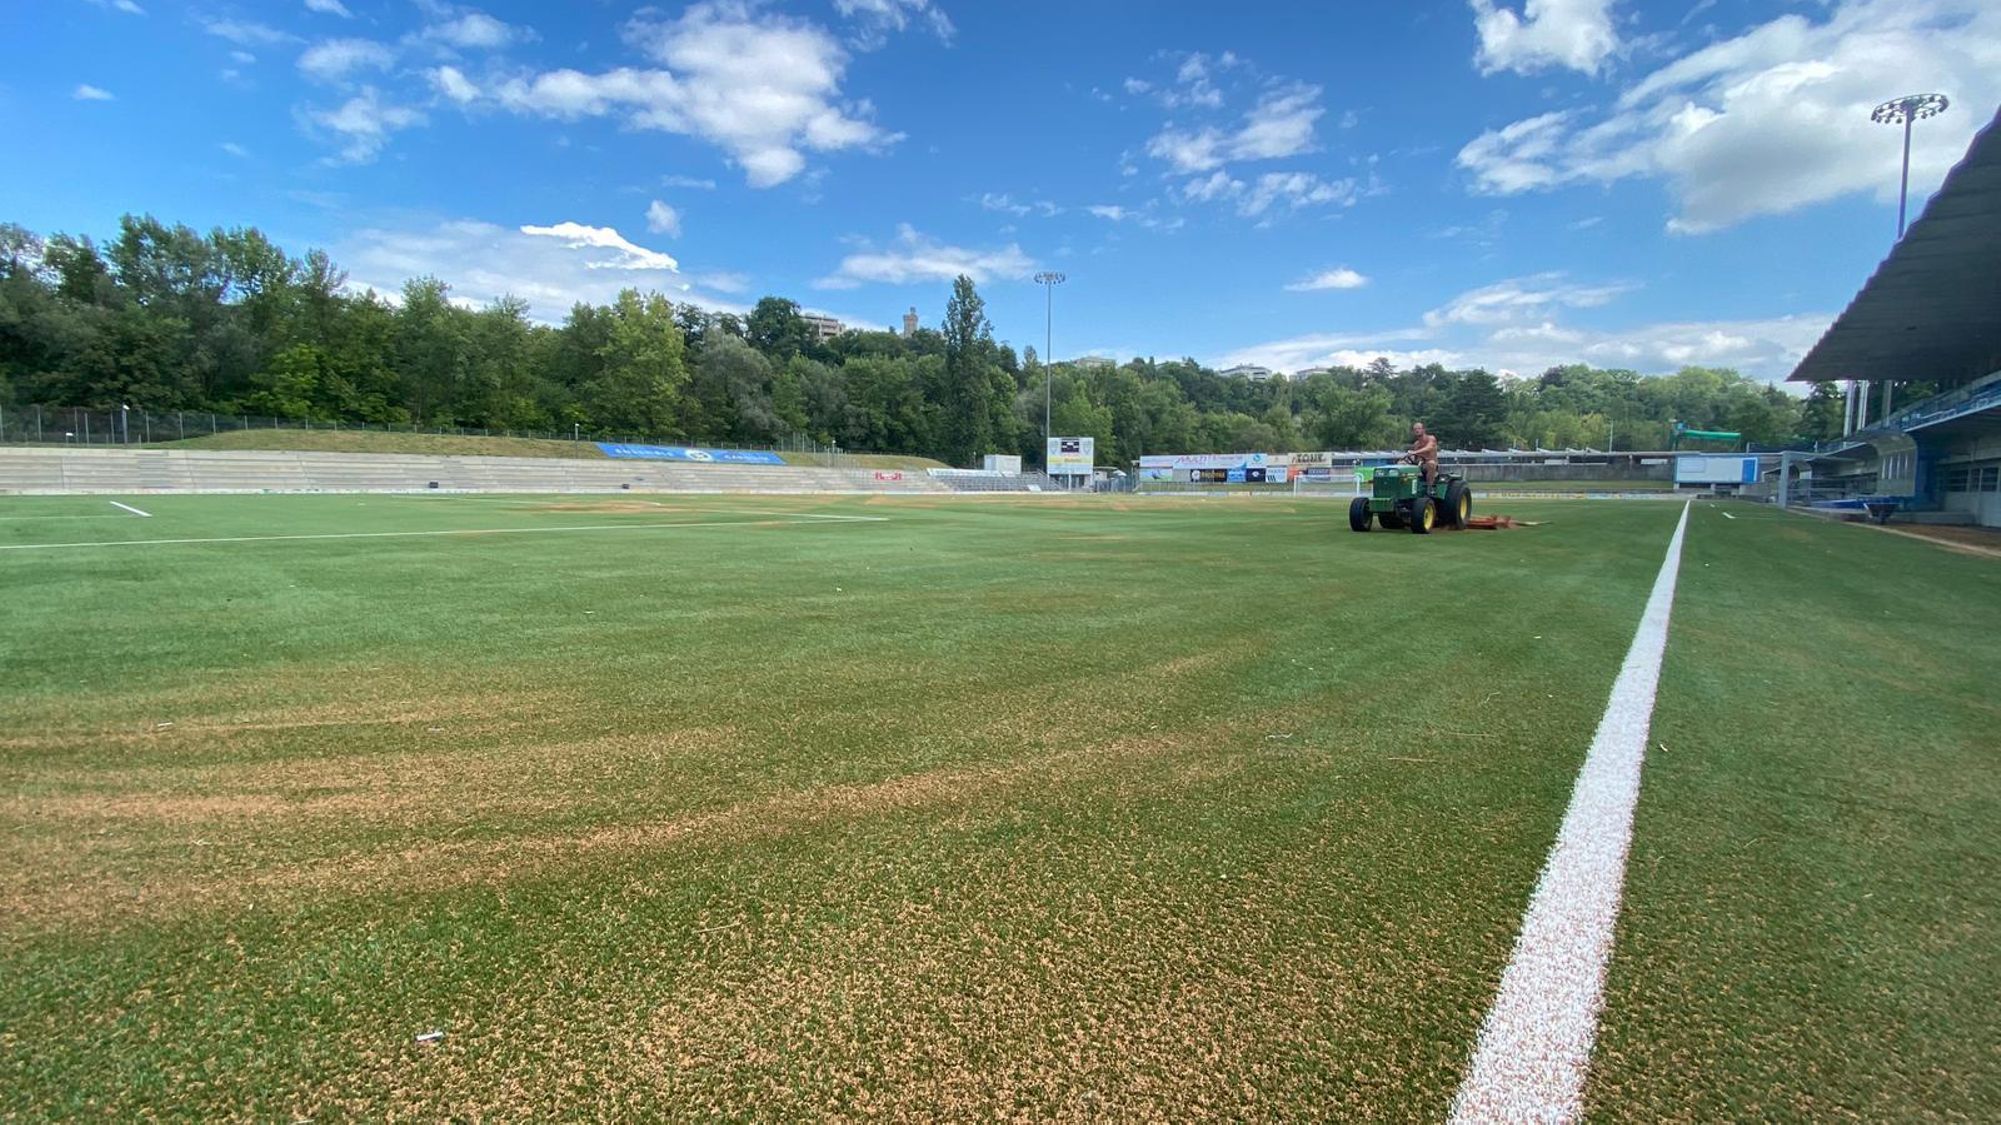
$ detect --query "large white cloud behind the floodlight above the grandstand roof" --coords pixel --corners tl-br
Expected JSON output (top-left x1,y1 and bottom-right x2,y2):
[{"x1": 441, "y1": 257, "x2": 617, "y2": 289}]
[{"x1": 1459, "y1": 0, "x2": 2001, "y2": 234}]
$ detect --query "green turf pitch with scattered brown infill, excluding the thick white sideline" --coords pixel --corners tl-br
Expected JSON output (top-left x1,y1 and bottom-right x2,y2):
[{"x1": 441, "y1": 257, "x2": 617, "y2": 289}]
[{"x1": 0, "y1": 496, "x2": 2001, "y2": 1121}]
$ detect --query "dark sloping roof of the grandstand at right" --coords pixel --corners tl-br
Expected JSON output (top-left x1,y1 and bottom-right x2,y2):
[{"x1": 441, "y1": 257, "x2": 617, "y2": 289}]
[{"x1": 1789, "y1": 112, "x2": 2001, "y2": 386}]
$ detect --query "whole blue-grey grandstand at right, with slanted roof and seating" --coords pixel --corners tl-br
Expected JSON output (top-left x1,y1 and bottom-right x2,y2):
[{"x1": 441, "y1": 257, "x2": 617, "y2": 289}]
[{"x1": 1779, "y1": 104, "x2": 2001, "y2": 526}]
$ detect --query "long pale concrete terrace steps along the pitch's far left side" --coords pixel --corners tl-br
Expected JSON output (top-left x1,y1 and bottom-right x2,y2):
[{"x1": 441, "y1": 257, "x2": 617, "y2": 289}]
[{"x1": 0, "y1": 446, "x2": 946, "y2": 492}]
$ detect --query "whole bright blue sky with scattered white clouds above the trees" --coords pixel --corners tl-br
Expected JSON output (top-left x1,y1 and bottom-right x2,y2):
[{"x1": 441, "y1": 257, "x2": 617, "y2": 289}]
[{"x1": 0, "y1": 0, "x2": 2001, "y2": 378}]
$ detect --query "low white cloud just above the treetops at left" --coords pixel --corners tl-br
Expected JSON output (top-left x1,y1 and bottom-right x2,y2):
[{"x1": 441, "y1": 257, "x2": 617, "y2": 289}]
[{"x1": 328, "y1": 220, "x2": 742, "y2": 322}]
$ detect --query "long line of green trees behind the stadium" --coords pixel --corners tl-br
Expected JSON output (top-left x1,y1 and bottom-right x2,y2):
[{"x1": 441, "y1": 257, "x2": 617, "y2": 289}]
[{"x1": 0, "y1": 216, "x2": 1841, "y2": 464}]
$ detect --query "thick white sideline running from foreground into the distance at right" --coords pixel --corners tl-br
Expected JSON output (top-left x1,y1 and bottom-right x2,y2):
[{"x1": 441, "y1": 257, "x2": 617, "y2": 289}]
[{"x1": 1453, "y1": 504, "x2": 1689, "y2": 1123}]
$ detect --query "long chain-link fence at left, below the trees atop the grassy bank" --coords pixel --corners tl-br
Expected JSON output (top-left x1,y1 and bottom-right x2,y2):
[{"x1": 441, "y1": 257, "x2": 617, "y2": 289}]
[{"x1": 0, "y1": 406, "x2": 866, "y2": 468}]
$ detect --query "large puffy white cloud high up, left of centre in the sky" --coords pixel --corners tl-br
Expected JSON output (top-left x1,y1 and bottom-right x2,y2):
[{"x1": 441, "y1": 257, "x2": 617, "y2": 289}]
[{"x1": 498, "y1": 0, "x2": 900, "y2": 188}]
